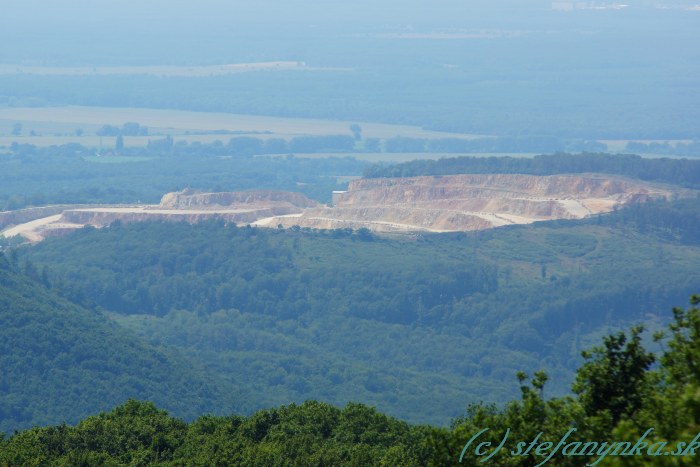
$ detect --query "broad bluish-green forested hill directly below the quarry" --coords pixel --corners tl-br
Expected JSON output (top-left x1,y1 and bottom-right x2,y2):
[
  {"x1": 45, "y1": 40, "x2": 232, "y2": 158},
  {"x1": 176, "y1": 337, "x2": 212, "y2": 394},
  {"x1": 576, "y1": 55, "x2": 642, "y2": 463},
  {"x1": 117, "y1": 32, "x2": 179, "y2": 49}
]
[{"x1": 16, "y1": 196, "x2": 700, "y2": 430}]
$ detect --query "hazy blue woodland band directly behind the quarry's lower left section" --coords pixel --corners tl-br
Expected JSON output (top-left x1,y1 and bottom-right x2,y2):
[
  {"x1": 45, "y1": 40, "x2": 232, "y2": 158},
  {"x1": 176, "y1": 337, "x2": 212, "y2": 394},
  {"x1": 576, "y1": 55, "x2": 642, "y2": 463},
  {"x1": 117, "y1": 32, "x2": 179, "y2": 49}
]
[{"x1": 0, "y1": 141, "x2": 368, "y2": 210}]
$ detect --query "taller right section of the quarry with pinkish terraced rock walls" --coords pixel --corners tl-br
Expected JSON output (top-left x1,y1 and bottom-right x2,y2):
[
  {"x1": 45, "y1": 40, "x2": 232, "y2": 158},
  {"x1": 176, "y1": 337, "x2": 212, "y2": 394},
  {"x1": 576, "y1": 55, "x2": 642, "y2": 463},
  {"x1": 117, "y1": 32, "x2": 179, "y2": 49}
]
[{"x1": 270, "y1": 174, "x2": 679, "y2": 232}]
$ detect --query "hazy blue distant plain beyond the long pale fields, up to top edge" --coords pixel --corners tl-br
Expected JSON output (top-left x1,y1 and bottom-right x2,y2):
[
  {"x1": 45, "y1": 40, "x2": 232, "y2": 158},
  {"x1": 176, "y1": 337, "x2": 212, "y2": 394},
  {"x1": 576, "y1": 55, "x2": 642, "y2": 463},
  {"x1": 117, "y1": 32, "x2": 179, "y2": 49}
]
[{"x1": 0, "y1": 0, "x2": 700, "y2": 139}]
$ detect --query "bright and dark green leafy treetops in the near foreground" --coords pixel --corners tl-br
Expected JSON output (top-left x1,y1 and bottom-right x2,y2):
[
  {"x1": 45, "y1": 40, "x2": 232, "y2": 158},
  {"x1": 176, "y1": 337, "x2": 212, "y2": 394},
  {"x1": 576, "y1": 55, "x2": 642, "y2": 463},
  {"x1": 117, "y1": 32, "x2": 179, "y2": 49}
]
[{"x1": 0, "y1": 296, "x2": 700, "y2": 467}]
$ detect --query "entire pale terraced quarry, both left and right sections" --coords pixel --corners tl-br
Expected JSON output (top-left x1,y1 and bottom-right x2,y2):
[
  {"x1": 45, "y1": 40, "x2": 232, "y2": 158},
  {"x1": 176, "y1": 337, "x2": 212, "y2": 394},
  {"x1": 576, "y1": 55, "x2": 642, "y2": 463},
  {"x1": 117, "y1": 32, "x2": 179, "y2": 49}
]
[{"x1": 0, "y1": 174, "x2": 691, "y2": 242}]
